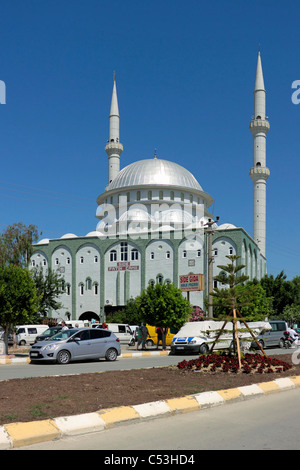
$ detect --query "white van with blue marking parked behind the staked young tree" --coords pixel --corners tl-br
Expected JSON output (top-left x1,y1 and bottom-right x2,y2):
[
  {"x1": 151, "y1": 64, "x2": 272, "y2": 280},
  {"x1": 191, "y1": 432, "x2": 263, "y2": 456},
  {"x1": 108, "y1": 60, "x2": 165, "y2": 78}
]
[{"x1": 171, "y1": 320, "x2": 271, "y2": 354}]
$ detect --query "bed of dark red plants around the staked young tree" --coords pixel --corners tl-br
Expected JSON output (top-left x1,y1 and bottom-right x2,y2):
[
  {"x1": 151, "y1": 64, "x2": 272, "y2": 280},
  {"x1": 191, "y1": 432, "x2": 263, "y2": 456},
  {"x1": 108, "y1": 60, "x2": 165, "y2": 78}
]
[{"x1": 177, "y1": 354, "x2": 292, "y2": 374}]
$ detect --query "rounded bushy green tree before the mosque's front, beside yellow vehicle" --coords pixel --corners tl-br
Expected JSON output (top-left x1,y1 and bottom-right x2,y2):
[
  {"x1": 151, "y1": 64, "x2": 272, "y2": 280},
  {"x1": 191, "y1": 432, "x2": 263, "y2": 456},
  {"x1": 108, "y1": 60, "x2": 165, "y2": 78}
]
[{"x1": 136, "y1": 283, "x2": 191, "y2": 348}]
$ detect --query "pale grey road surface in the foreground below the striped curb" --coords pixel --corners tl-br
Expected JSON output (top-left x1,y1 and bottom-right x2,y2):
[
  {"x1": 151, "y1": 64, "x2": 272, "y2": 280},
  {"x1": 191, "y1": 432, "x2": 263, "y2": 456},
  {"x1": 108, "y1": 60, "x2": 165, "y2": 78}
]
[{"x1": 17, "y1": 389, "x2": 300, "y2": 452}]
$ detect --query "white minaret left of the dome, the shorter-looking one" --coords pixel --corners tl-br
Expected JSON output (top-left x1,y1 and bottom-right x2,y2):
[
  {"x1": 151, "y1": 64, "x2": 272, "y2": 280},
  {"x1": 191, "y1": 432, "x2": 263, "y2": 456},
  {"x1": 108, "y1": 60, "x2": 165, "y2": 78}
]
[{"x1": 105, "y1": 74, "x2": 123, "y2": 184}]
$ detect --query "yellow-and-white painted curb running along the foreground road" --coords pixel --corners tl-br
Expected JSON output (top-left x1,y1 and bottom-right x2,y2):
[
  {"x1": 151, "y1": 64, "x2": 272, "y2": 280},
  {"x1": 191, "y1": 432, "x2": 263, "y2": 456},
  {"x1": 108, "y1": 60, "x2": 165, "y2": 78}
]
[{"x1": 0, "y1": 376, "x2": 300, "y2": 450}]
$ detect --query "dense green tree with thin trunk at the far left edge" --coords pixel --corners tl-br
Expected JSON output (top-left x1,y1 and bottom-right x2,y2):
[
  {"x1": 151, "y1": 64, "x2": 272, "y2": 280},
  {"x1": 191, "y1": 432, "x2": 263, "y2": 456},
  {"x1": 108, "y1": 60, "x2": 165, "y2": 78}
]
[{"x1": 0, "y1": 266, "x2": 38, "y2": 354}]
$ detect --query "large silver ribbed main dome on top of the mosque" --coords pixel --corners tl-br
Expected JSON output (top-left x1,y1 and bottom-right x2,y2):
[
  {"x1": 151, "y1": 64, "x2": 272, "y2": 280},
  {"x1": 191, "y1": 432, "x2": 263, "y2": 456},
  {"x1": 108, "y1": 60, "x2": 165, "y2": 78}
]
[{"x1": 106, "y1": 158, "x2": 203, "y2": 191}]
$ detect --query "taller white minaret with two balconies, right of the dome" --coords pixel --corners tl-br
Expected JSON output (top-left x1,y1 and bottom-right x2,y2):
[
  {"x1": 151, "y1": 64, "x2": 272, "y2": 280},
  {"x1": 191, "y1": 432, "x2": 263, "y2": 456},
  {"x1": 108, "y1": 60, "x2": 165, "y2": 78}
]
[{"x1": 249, "y1": 51, "x2": 270, "y2": 256}]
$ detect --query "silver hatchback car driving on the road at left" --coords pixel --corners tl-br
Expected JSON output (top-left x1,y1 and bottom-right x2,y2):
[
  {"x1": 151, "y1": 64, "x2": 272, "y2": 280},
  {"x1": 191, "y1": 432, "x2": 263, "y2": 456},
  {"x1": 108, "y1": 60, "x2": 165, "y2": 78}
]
[{"x1": 29, "y1": 328, "x2": 121, "y2": 364}]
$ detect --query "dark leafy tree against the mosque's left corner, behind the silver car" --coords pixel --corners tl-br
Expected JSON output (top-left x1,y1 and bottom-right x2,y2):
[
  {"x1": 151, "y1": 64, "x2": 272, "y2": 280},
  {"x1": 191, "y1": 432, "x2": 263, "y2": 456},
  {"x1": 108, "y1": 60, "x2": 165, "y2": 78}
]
[{"x1": 31, "y1": 266, "x2": 64, "y2": 317}]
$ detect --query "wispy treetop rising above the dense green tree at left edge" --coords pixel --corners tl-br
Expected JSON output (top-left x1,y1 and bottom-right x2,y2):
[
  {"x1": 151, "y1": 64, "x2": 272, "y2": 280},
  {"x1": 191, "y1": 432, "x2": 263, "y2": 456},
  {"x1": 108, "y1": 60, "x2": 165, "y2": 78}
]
[{"x1": 0, "y1": 222, "x2": 39, "y2": 267}]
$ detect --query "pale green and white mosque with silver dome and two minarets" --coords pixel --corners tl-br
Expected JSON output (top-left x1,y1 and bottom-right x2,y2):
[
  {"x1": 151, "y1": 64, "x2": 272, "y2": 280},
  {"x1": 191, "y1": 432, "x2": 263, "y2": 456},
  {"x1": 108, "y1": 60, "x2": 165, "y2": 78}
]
[{"x1": 31, "y1": 52, "x2": 270, "y2": 321}]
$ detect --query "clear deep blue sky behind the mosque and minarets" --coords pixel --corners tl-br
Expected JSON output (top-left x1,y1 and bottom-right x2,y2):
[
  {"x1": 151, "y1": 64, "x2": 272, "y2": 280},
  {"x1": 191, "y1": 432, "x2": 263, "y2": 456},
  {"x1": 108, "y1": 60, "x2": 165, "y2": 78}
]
[{"x1": 0, "y1": 0, "x2": 300, "y2": 279}]
